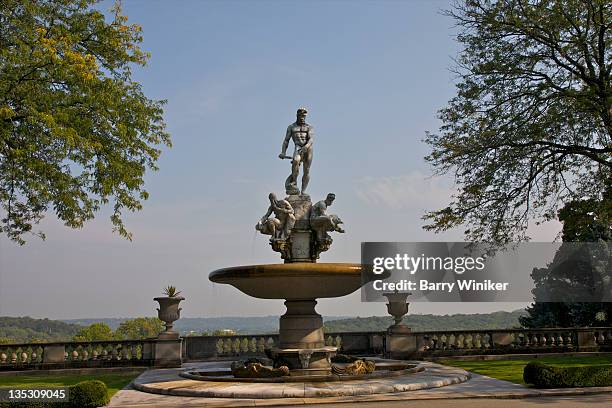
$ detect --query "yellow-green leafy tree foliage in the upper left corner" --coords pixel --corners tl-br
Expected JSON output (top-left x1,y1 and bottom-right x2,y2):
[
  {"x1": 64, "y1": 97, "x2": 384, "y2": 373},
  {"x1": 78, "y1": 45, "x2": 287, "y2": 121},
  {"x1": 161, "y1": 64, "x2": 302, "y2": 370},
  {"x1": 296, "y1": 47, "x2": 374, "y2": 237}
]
[{"x1": 0, "y1": 0, "x2": 170, "y2": 244}]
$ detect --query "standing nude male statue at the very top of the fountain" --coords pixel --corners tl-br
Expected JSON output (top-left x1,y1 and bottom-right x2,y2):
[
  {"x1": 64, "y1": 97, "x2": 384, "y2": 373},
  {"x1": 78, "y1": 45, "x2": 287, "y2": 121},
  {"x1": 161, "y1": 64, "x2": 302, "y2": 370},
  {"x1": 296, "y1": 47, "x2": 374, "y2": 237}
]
[{"x1": 278, "y1": 108, "x2": 314, "y2": 195}]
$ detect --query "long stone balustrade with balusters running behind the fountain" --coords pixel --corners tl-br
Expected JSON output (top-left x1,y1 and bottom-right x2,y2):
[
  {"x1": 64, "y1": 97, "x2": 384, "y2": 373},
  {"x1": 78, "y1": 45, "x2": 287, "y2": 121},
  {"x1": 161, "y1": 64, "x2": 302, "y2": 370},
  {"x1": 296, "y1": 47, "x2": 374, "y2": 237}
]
[{"x1": 0, "y1": 327, "x2": 612, "y2": 371}]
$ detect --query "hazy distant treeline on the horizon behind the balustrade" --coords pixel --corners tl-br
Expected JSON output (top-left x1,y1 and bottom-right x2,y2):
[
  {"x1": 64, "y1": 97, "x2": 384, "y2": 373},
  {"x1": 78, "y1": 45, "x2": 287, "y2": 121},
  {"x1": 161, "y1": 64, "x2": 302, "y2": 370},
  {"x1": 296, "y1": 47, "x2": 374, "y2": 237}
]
[{"x1": 0, "y1": 310, "x2": 526, "y2": 343}]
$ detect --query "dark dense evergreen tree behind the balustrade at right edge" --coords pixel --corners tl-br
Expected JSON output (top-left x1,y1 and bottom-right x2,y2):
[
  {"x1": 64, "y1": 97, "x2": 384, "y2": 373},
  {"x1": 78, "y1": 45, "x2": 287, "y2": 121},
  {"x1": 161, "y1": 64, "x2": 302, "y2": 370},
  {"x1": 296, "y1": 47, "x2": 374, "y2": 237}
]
[{"x1": 519, "y1": 189, "x2": 612, "y2": 327}]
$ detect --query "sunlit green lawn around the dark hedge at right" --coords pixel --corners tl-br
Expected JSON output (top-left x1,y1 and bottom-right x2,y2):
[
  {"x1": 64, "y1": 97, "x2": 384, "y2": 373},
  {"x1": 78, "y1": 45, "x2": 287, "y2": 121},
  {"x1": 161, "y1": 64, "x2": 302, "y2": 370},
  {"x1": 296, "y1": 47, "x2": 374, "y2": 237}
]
[{"x1": 439, "y1": 356, "x2": 612, "y2": 385}]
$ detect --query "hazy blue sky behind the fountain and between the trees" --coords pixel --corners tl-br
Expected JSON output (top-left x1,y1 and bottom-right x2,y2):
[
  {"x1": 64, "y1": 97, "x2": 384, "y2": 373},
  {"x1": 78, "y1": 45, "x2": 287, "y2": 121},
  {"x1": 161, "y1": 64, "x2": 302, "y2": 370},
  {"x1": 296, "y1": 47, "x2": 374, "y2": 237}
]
[{"x1": 0, "y1": 0, "x2": 558, "y2": 318}]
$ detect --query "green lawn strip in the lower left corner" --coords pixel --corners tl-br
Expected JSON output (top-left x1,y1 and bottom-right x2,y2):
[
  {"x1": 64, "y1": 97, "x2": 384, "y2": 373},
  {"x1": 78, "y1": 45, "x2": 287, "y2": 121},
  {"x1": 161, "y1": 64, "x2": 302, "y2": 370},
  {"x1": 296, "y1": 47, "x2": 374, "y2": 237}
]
[{"x1": 0, "y1": 373, "x2": 138, "y2": 397}]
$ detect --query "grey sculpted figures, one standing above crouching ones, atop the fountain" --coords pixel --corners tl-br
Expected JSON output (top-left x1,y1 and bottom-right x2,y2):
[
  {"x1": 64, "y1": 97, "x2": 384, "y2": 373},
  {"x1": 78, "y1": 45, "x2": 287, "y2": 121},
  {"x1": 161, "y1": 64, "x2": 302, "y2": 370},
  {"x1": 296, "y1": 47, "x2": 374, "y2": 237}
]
[{"x1": 255, "y1": 108, "x2": 344, "y2": 262}]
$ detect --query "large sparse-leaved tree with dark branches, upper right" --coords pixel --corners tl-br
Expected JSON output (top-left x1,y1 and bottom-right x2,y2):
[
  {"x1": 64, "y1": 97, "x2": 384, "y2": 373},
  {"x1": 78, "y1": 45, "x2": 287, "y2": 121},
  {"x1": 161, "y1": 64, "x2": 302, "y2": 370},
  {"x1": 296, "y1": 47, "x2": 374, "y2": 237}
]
[{"x1": 424, "y1": 0, "x2": 612, "y2": 244}]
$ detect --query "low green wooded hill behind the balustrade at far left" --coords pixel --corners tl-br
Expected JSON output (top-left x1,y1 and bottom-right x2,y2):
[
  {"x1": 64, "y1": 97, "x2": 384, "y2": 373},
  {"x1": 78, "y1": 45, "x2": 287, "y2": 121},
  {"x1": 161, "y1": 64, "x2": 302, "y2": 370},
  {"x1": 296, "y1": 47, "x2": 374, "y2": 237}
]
[{"x1": 0, "y1": 316, "x2": 82, "y2": 343}]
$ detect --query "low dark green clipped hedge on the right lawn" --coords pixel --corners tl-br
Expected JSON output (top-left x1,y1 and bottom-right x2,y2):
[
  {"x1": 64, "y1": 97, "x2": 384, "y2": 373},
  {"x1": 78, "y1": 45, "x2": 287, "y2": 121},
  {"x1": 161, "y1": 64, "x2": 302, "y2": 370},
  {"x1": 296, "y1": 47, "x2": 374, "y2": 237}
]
[{"x1": 523, "y1": 361, "x2": 612, "y2": 388}]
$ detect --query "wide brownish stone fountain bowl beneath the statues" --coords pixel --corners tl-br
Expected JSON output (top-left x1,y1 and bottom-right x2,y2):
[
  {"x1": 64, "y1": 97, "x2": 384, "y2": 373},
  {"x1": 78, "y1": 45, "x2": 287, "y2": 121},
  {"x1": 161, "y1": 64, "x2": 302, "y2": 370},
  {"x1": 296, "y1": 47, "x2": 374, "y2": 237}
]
[{"x1": 208, "y1": 262, "x2": 365, "y2": 300}]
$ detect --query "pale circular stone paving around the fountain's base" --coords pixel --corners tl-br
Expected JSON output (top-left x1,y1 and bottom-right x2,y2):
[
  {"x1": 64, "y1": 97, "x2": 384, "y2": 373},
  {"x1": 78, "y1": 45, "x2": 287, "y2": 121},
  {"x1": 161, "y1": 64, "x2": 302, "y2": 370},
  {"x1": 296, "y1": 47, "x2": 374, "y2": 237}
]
[{"x1": 132, "y1": 362, "x2": 470, "y2": 399}]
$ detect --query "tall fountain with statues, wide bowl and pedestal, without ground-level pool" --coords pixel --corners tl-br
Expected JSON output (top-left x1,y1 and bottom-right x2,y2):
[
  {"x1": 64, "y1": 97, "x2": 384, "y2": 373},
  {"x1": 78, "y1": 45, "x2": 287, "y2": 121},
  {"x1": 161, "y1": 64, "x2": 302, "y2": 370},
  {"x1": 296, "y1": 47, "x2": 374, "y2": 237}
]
[{"x1": 209, "y1": 108, "x2": 363, "y2": 375}]
